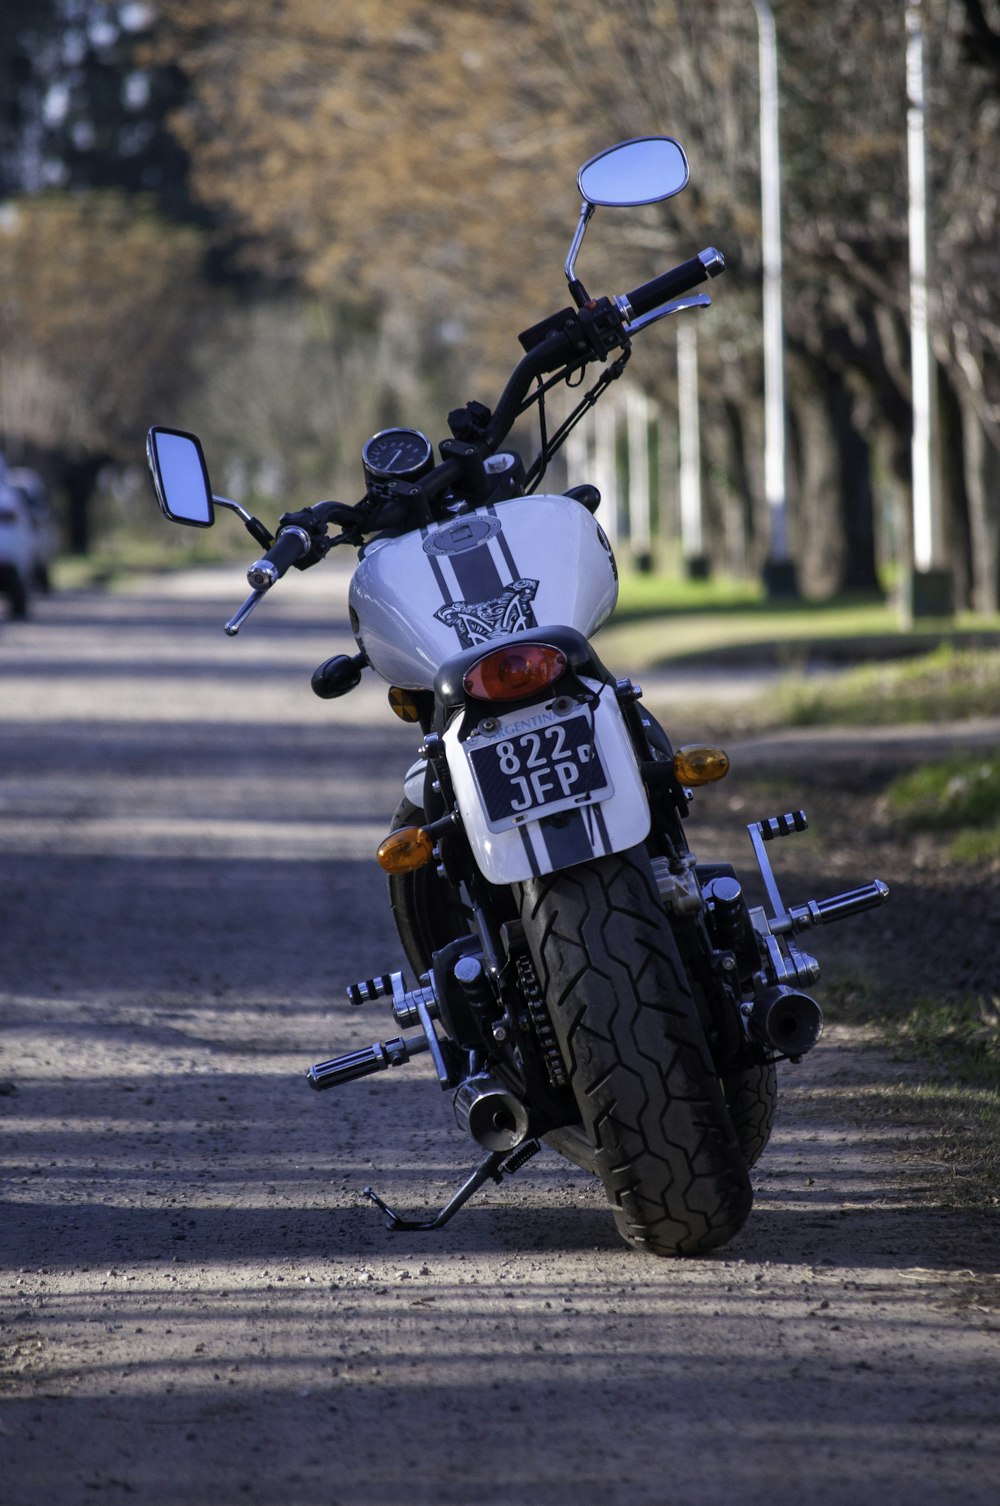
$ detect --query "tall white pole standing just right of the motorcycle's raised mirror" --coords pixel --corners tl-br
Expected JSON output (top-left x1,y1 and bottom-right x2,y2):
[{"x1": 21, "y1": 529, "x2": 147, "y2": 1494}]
[{"x1": 753, "y1": 0, "x2": 798, "y2": 596}]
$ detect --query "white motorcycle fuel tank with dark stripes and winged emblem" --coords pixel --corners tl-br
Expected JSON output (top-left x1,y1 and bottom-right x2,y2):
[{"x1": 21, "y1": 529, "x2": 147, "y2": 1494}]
[{"x1": 348, "y1": 495, "x2": 617, "y2": 690}]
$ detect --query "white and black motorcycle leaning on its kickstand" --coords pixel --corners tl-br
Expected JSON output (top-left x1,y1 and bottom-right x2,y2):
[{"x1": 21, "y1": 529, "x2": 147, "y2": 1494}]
[{"x1": 148, "y1": 137, "x2": 889, "y2": 1256}]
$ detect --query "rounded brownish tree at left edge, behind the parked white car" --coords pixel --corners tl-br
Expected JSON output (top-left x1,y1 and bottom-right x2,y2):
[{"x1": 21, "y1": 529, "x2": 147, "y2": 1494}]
[{"x1": 0, "y1": 193, "x2": 203, "y2": 551}]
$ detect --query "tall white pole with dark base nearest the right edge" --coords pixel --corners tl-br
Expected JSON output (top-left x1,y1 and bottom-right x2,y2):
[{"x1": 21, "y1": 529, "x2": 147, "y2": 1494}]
[{"x1": 904, "y1": 0, "x2": 953, "y2": 622}]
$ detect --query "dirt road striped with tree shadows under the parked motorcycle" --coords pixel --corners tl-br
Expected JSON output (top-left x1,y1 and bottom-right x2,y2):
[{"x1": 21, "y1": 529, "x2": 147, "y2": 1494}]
[{"x1": 0, "y1": 571, "x2": 1000, "y2": 1506}]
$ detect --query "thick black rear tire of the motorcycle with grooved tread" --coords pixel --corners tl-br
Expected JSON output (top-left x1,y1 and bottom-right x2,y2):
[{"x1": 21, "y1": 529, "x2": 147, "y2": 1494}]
[{"x1": 520, "y1": 848, "x2": 753, "y2": 1256}]
